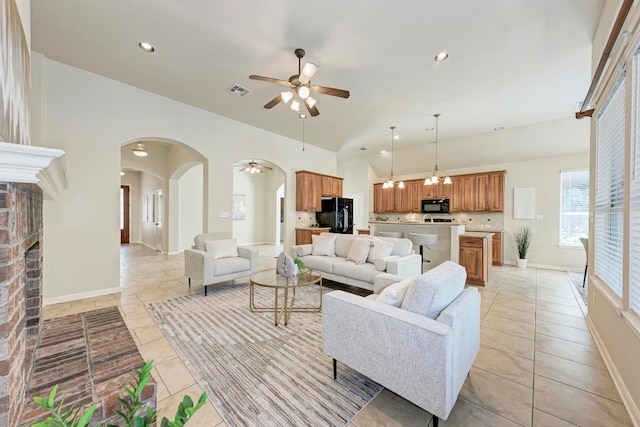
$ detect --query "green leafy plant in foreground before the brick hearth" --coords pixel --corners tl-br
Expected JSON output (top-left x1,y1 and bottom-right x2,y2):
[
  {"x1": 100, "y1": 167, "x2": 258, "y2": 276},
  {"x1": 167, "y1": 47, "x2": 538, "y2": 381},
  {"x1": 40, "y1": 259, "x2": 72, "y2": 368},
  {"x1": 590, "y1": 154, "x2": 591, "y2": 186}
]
[{"x1": 31, "y1": 360, "x2": 207, "y2": 427}]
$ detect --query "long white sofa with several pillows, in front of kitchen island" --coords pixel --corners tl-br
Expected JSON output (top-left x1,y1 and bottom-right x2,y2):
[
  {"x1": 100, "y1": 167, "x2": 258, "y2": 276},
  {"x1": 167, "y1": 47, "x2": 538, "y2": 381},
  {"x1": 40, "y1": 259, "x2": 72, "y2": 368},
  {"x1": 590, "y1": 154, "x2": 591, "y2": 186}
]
[{"x1": 292, "y1": 233, "x2": 422, "y2": 290}]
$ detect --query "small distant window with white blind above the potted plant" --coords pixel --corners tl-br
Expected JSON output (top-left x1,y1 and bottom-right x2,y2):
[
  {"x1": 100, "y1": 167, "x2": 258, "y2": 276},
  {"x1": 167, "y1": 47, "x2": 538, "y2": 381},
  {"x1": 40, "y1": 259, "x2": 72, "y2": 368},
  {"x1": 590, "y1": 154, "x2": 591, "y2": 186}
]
[{"x1": 559, "y1": 169, "x2": 589, "y2": 246}]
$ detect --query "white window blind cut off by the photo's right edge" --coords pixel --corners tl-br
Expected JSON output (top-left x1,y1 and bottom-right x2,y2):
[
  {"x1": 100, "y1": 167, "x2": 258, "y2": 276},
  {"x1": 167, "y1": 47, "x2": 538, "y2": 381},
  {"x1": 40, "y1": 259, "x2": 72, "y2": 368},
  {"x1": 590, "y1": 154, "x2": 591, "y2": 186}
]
[{"x1": 629, "y1": 52, "x2": 640, "y2": 314}]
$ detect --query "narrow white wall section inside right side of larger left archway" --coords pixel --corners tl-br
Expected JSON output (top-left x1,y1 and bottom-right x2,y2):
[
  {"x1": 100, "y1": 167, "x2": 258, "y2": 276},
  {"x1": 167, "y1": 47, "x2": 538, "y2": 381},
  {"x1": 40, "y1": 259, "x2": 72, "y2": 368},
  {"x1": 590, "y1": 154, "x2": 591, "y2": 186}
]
[{"x1": 178, "y1": 164, "x2": 203, "y2": 251}]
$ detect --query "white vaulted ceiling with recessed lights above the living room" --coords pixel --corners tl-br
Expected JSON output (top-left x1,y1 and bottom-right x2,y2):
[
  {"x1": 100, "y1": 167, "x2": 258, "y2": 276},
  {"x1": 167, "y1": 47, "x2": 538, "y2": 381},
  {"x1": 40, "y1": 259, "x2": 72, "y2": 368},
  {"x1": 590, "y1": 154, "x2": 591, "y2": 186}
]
[{"x1": 31, "y1": 0, "x2": 605, "y2": 173}]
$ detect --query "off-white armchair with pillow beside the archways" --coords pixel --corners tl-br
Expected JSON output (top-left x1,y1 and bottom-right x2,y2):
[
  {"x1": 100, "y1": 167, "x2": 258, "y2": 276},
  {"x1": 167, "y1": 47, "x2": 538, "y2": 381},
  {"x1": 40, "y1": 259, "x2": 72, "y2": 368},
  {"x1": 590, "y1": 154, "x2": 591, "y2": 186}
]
[{"x1": 184, "y1": 232, "x2": 258, "y2": 295}]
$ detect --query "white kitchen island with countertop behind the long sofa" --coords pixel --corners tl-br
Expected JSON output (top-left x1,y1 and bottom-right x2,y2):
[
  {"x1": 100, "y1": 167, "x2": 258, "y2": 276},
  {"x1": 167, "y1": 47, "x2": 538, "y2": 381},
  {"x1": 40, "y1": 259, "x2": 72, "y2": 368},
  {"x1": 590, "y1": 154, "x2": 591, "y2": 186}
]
[{"x1": 369, "y1": 221, "x2": 465, "y2": 271}]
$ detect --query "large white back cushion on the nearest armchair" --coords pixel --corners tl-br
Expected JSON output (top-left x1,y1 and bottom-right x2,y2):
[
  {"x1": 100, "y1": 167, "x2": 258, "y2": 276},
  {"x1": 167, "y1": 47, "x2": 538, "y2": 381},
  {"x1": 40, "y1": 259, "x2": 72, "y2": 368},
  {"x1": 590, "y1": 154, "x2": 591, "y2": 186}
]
[{"x1": 401, "y1": 261, "x2": 467, "y2": 319}]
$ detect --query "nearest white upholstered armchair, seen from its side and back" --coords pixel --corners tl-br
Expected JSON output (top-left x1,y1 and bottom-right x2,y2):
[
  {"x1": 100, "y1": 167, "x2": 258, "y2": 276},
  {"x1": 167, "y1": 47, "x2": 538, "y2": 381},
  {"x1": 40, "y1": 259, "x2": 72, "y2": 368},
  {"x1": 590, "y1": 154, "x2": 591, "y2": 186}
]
[{"x1": 322, "y1": 261, "x2": 480, "y2": 426}]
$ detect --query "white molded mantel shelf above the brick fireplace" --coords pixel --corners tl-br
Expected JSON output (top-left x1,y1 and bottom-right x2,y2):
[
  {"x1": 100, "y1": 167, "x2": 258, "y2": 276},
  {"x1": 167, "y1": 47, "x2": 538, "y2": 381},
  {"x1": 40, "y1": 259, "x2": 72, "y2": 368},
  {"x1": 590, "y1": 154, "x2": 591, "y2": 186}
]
[{"x1": 0, "y1": 141, "x2": 67, "y2": 199}]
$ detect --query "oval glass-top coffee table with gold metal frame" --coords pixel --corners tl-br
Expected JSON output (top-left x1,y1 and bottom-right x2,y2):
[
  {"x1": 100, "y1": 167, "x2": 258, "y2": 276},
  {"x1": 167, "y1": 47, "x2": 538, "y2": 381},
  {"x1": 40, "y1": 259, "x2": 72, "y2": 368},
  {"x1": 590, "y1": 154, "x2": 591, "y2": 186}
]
[{"x1": 249, "y1": 270, "x2": 322, "y2": 326}]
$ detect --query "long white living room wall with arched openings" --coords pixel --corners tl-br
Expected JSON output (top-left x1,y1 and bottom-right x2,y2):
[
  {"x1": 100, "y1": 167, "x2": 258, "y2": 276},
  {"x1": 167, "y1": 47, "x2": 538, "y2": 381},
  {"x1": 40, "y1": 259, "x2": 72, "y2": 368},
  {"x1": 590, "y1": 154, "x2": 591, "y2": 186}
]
[{"x1": 32, "y1": 52, "x2": 336, "y2": 303}]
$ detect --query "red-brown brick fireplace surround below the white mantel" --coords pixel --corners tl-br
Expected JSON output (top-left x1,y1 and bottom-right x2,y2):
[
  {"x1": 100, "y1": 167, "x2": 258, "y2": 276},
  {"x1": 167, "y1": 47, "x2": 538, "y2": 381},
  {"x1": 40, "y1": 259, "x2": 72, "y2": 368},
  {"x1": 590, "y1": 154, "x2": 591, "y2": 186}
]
[{"x1": 0, "y1": 182, "x2": 43, "y2": 426}]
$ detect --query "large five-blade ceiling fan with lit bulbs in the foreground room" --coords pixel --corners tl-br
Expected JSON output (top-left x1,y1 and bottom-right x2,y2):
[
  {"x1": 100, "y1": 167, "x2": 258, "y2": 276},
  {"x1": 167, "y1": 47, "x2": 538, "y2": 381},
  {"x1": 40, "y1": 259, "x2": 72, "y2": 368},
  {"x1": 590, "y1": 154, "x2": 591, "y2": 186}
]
[{"x1": 249, "y1": 48, "x2": 350, "y2": 117}]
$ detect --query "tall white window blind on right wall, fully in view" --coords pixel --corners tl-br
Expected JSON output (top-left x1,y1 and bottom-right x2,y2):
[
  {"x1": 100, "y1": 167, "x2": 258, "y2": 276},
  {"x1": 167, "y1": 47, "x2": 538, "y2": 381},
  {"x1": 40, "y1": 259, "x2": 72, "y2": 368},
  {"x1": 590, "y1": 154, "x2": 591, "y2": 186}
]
[{"x1": 593, "y1": 75, "x2": 625, "y2": 298}]
